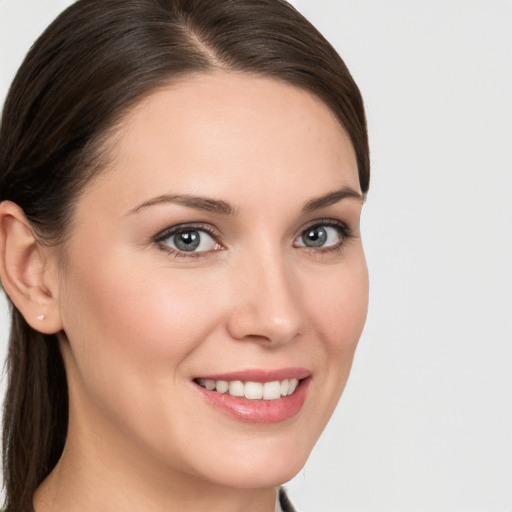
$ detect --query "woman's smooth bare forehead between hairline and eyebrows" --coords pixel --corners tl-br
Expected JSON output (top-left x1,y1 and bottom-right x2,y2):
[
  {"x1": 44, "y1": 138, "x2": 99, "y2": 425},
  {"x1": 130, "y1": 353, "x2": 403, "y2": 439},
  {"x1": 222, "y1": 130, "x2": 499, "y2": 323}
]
[{"x1": 82, "y1": 72, "x2": 360, "y2": 214}]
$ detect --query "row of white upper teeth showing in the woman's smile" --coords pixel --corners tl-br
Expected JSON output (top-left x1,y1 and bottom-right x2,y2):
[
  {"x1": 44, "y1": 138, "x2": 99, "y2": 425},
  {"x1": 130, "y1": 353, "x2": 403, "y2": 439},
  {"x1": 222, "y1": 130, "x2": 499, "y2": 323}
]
[{"x1": 197, "y1": 379, "x2": 299, "y2": 400}]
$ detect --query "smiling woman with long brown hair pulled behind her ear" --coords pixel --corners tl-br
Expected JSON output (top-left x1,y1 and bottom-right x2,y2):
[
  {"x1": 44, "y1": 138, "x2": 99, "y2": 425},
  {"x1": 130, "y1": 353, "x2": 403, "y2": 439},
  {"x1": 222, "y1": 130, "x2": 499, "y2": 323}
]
[{"x1": 0, "y1": 0, "x2": 369, "y2": 512}]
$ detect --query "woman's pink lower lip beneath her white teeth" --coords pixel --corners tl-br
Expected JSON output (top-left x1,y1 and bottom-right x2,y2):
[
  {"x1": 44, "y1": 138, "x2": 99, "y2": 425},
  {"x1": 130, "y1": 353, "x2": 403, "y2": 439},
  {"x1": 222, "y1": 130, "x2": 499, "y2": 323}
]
[{"x1": 195, "y1": 377, "x2": 311, "y2": 424}]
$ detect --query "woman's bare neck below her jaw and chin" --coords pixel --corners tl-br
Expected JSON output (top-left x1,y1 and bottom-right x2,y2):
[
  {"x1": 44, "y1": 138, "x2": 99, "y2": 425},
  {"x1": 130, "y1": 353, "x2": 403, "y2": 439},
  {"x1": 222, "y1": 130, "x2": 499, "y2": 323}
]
[{"x1": 34, "y1": 414, "x2": 276, "y2": 512}]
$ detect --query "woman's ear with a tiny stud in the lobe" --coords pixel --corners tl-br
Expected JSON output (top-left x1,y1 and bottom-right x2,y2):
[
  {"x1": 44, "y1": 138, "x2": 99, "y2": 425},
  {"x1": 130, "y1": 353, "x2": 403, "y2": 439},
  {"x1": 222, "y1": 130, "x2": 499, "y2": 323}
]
[{"x1": 0, "y1": 201, "x2": 62, "y2": 334}]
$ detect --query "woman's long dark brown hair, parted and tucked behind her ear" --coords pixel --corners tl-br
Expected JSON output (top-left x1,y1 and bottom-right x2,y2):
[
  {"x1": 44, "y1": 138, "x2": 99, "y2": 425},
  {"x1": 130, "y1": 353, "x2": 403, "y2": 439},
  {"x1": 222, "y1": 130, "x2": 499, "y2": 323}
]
[{"x1": 0, "y1": 0, "x2": 369, "y2": 512}]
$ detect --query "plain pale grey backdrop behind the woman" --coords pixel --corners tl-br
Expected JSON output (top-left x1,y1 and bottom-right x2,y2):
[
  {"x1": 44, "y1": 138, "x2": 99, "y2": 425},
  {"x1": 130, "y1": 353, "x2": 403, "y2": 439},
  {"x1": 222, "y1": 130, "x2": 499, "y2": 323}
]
[{"x1": 0, "y1": 0, "x2": 512, "y2": 512}]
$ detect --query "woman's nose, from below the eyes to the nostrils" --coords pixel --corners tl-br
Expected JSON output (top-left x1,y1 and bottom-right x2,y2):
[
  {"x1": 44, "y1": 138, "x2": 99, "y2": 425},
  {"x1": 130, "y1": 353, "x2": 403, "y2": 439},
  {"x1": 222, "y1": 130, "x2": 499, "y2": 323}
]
[{"x1": 228, "y1": 250, "x2": 303, "y2": 347}]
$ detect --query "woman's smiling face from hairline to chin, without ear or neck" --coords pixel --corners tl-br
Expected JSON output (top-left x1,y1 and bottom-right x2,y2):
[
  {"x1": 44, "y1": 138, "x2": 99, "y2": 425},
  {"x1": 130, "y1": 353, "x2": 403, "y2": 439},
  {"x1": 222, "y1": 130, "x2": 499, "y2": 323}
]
[{"x1": 52, "y1": 73, "x2": 368, "y2": 487}]
